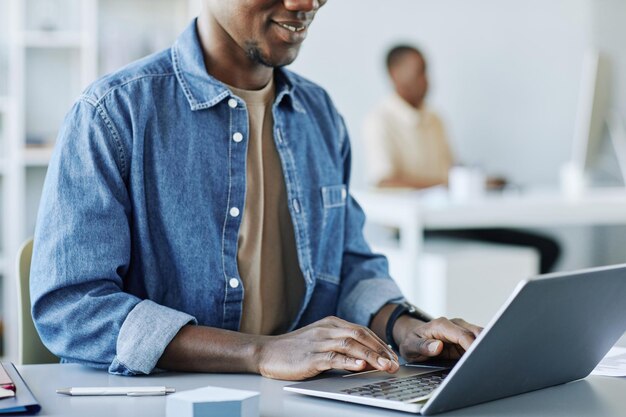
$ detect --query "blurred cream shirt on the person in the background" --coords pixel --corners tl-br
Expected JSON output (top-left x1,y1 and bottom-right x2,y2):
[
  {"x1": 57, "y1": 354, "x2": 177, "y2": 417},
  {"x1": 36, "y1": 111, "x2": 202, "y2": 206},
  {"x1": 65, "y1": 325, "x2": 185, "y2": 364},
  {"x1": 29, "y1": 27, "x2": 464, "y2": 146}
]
[{"x1": 363, "y1": 94, "x2": 453, "y2": 185}]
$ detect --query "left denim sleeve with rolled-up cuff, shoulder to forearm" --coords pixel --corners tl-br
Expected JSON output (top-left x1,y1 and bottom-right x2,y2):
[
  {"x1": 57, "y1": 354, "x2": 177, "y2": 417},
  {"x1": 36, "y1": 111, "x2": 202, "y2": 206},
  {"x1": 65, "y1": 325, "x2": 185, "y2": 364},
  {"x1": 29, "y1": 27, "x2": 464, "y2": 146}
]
[{"x1": 30, "y1": 97, "x2": 196, "y2": 375}]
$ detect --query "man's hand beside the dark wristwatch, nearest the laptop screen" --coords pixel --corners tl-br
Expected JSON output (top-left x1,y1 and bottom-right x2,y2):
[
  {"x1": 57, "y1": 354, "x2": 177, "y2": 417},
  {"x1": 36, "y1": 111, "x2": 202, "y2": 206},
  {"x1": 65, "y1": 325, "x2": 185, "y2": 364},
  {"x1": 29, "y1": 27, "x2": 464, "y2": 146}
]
[{"x1": 393, "y1": 316, "x2": 482, "y2": 362}]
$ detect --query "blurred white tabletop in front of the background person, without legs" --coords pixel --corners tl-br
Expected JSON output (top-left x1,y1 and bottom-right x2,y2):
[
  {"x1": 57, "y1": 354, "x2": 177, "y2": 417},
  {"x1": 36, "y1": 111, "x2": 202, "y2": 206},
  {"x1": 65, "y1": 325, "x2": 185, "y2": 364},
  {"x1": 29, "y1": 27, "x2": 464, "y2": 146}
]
[{"x1": 353, "y1": 188, "x2": 626, "y2": 229}]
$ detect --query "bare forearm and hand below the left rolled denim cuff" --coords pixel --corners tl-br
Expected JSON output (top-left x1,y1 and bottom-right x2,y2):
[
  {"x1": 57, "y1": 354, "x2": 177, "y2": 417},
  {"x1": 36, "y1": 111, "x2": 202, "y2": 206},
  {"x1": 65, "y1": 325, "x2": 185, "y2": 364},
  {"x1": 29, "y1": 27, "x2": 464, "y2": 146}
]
[{"x1": 157, "y1": 317, "x2": 398, "y2": 380}]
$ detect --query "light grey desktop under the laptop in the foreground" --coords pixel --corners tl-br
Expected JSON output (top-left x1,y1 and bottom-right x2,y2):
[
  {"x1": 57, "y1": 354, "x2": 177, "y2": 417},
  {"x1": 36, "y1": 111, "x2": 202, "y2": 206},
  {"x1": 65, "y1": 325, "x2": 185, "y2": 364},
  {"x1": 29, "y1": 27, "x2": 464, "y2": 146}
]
[{"x1": 17, "y1": 364, "x2": 626, "y2": 417}]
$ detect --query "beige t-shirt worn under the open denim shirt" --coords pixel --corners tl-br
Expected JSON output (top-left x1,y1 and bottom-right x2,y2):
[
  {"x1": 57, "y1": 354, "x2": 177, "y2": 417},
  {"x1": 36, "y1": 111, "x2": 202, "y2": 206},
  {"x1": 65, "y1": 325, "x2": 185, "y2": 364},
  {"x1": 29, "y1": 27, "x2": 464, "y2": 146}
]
[{"x1": 230, "y1": 81, "x2": 304, "y2": 334}]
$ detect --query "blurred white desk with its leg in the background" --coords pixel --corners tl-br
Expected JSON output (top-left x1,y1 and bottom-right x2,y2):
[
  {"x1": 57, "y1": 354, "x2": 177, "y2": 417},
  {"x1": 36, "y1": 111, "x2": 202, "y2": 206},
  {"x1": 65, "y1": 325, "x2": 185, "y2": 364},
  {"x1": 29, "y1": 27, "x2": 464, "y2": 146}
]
[{"x1": 353, "y1": 188, "x2": 626, "y2": 316}]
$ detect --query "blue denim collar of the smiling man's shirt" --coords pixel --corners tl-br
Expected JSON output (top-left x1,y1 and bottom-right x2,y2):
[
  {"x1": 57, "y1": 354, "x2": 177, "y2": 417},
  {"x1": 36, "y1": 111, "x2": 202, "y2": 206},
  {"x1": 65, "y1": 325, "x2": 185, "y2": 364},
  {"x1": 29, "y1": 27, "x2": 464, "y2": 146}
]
[{"x1": 172, "y1": 19, "x2": 303, "y2": 112}]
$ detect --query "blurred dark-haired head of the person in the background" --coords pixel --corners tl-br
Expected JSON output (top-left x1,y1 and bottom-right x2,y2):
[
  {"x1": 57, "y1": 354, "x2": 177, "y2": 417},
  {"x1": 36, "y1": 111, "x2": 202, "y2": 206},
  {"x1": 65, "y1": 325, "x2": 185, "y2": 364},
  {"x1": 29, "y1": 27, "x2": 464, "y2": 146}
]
[{"x1": 387, "y1": 45, "x2": 428, "y2": 108}]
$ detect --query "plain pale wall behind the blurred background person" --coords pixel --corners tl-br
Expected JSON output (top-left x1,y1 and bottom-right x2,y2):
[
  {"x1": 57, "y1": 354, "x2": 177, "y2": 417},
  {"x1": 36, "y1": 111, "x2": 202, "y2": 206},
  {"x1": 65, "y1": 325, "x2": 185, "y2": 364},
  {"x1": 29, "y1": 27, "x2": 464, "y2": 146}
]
[{"x1": 293, "y1": 0, "x2": 592, "y2": 184}]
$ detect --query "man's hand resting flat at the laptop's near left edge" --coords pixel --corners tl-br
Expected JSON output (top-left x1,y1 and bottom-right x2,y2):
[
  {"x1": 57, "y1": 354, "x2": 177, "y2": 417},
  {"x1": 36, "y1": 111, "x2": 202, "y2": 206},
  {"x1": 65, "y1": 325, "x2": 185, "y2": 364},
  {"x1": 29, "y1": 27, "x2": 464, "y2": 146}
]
[{"x1": 258, "y1": 317, "x2": 399, "y2": 380}]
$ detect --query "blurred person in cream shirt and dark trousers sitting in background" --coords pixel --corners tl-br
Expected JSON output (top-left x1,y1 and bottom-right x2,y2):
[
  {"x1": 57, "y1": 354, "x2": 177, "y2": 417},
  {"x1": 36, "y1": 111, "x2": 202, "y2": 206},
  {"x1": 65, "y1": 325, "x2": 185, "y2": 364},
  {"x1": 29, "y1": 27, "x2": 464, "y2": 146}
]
[{"x1": 363, "y1": 45, "x2": 561, "y2": 273}]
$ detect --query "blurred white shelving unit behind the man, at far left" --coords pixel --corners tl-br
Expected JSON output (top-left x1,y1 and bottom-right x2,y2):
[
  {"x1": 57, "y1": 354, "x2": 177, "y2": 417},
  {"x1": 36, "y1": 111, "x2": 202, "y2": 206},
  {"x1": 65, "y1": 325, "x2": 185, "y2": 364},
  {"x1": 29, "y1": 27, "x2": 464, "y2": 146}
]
[{"x1": 0, "y1": 0, "x2": 201, "y2": 360}]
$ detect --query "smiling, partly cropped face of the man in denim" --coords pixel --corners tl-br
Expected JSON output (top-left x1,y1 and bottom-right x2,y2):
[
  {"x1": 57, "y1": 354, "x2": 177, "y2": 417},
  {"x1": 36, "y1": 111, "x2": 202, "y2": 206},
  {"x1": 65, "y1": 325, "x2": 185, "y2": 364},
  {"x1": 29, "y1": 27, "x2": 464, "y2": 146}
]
[{"x1": 201, "y1": 0, "x2": 327, "y2": 67}]
